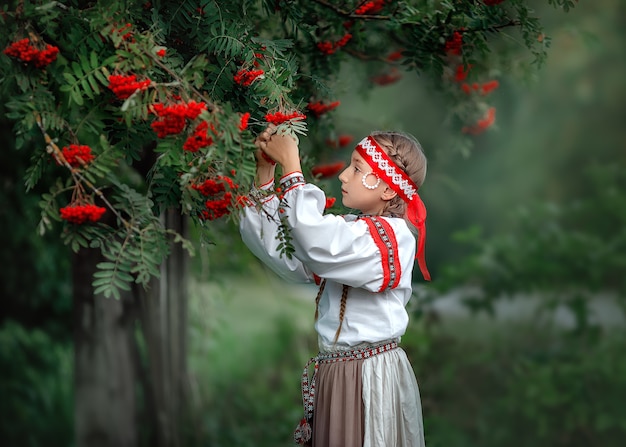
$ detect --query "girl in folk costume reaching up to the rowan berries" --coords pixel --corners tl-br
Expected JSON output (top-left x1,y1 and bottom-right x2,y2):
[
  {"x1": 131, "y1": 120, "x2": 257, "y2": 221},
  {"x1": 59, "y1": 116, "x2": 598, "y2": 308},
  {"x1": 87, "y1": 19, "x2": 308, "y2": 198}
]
[{"x1": 240, "y1": 126, "x2": 430, "y2": 447}]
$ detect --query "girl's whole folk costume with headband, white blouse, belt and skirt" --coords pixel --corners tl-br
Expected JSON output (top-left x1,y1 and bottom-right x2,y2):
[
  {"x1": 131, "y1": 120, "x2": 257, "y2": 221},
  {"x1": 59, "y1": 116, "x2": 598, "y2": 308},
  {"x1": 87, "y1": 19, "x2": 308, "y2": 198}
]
[{"x1": 240, "y1": 136, "x2": 427, "y2": 447}]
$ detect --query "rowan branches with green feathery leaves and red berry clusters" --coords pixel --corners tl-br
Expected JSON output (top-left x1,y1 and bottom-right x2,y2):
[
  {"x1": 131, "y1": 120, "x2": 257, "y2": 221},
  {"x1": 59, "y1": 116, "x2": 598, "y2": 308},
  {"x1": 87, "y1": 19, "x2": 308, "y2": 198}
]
[{"x1": 0, "y1": 0, "x2": 573, "y2": 295}]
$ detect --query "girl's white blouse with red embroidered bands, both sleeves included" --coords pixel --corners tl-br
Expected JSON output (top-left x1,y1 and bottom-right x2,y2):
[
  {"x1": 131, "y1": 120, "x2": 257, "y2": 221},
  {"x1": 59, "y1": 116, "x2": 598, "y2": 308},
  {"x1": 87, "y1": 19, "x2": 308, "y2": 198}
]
[{"x1": 240, "y1": 172, "x2": 416, "y2": 351}]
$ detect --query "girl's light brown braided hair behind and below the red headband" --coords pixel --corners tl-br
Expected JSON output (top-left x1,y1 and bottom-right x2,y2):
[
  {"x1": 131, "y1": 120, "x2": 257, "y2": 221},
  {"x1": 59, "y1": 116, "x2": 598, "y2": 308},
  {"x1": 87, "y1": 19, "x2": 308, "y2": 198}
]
[{"x1": 370, "y1": 131, "x2": 427, "y2": 221}]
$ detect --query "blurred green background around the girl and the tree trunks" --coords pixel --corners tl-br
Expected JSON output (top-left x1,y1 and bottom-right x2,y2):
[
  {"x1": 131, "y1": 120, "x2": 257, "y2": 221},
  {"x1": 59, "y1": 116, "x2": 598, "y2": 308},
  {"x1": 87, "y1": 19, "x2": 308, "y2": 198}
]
[{"x1": 0, "y1": 0, "x2": 626, "y2": 447}]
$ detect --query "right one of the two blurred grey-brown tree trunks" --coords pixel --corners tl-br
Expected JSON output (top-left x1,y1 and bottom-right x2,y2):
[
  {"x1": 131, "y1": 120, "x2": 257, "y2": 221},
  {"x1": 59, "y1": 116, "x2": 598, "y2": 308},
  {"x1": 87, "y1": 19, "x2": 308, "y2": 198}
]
[{"x1": 139, "y1": 209, "x2": 188, "y2": 447}]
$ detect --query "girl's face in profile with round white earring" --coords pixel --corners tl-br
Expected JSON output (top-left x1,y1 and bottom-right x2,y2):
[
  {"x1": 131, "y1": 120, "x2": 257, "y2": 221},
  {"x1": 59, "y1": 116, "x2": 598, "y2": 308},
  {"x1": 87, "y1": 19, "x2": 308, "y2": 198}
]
[{"x1": 339, "y1": 150, "x2": 389, "y2": 215}]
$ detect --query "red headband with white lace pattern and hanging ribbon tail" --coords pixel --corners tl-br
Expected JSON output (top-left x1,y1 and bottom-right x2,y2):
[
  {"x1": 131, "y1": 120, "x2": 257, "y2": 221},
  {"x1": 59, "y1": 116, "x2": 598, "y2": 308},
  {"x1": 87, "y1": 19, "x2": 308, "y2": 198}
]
[{"x1": 356, "y1": 136, "x2": 430, "y2": 281}]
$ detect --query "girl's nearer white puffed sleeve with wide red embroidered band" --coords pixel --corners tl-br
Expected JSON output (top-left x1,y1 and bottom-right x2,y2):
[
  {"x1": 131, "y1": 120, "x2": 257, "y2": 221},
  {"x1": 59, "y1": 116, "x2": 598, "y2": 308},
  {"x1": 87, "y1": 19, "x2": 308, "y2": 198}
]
[{"x1": 279, "y1": 180, "x2": 415, "y2": 292}]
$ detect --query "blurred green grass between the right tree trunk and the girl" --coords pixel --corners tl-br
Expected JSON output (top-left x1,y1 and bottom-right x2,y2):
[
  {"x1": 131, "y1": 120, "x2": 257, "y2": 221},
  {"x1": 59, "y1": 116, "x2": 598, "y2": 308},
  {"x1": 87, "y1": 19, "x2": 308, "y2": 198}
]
[{"x1": 183, "y1": 267, "x2": 316, "y2": 447}]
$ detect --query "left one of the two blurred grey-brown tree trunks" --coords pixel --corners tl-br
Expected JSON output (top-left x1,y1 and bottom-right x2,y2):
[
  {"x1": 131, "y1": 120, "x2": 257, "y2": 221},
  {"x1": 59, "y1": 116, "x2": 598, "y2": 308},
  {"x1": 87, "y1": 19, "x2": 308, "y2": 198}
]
[{"x1": 72, "y1": 249, "x2": 137, "y2": 447}]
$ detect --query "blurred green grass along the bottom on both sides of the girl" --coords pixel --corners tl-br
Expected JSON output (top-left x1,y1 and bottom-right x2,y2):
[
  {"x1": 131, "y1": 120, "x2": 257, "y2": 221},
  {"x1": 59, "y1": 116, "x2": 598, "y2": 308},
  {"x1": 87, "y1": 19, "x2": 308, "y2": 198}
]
[{"x1": 188, "y1": 266, "x2": 626, "y2": 447}]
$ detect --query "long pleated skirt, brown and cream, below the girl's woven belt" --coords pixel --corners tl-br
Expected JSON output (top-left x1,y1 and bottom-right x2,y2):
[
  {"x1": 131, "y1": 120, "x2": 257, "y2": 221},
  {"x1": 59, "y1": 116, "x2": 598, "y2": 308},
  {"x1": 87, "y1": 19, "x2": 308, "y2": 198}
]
[{"x1": 311, "y1": 348, "x2": 424, "y2": 447}]
